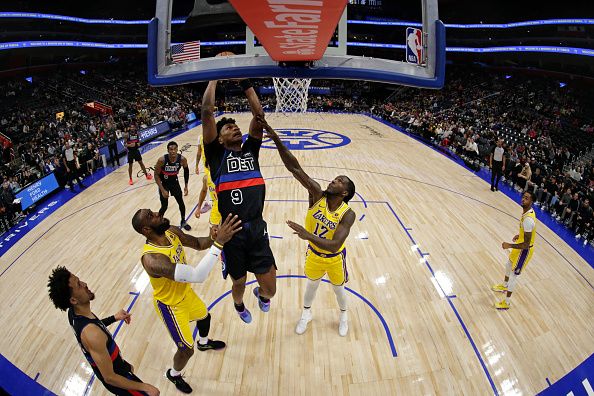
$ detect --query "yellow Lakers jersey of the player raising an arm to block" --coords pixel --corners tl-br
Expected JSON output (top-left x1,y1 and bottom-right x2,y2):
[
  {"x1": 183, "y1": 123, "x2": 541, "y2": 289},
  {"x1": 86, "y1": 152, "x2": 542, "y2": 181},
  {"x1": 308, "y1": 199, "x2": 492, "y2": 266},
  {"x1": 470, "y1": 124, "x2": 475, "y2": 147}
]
[{"x1": 305, "y1": 196, "x2": 350, "y2": 254}]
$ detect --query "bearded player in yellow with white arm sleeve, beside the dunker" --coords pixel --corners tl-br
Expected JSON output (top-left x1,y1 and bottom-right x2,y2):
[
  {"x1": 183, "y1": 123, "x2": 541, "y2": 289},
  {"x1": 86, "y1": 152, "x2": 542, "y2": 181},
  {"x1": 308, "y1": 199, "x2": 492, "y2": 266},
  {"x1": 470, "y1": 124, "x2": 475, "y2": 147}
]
[{"x1": 132, "y1": 209, "x2": 241, "y2": 393}]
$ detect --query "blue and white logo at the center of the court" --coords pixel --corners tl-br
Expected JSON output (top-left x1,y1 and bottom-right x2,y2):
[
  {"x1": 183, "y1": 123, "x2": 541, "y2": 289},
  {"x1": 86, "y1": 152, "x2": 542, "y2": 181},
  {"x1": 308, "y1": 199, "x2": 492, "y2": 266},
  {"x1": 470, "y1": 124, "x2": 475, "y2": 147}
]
[{"x1": 262, "y1": 128, "x2": 351, "y2": 150}]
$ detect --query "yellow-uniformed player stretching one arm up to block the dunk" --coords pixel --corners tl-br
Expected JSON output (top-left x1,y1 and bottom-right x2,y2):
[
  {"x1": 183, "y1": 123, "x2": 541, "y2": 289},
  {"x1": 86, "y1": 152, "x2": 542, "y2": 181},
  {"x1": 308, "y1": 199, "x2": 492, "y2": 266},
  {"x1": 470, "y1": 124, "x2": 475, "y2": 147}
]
[{"x1": 261, "y1": 120, "x2": 356, "y2": 337}]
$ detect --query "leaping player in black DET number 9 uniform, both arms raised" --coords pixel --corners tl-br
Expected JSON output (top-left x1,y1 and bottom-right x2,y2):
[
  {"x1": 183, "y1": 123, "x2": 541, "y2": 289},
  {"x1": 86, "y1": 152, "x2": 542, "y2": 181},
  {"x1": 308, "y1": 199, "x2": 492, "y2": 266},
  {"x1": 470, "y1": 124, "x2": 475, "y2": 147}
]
[{"x1": 202, "y1": 80, "x2": 276, "y2": 323}]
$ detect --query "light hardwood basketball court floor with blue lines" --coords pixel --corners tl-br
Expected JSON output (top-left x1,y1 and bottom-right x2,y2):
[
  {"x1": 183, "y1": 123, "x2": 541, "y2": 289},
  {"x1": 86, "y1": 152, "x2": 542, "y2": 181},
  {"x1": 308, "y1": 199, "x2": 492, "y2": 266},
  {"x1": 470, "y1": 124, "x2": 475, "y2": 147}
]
[{"x1": 0, "y1": 114, "x2": 594, "y2": 395}]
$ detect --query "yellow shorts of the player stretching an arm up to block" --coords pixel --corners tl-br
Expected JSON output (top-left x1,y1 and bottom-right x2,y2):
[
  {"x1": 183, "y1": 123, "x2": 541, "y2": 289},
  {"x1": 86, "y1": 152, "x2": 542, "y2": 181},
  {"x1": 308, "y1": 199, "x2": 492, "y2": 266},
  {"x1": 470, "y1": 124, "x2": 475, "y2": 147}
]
[{"x1": 305, "y1": 246, "x2": 349, "y2": 286}]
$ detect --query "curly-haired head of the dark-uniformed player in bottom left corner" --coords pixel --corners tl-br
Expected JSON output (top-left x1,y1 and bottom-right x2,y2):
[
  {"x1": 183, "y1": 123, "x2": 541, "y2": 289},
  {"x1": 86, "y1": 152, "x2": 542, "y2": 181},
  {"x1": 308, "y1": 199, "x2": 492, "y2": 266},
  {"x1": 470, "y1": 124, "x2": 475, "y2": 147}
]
[{"x1": 47, "y1": 267, "x2": 95, "y2": 311}]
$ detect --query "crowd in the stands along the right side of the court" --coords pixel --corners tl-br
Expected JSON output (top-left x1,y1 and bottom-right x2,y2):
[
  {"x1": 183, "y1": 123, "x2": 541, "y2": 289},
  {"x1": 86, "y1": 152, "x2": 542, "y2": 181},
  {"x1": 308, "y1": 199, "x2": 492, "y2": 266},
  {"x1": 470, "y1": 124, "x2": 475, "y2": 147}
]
[{"x1": 372, "y1": 70, "x2": 594, "y2": 245}]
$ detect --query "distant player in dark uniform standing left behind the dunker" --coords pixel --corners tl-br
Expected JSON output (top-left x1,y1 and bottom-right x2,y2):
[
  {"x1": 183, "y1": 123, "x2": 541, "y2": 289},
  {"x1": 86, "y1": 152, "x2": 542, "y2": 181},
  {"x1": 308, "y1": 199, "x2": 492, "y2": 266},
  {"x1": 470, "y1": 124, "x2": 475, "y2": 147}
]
[{"x1": 155, "y1": 141, "x2": 192, "y2": 230}]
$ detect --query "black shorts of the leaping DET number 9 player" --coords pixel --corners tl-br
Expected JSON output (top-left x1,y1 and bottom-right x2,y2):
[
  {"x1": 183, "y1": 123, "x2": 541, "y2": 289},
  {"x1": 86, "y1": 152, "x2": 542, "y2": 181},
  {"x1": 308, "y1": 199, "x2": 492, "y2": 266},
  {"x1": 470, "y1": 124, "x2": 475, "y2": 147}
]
[{"x1": 221, "y1": 219, "x2": 276, "y2": 280}]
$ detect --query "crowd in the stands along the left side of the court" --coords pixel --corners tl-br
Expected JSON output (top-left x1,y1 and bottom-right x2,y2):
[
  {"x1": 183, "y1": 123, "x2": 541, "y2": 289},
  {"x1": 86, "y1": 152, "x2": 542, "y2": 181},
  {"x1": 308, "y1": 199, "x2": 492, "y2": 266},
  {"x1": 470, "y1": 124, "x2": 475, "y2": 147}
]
[{"x1": 0, "y1": 69, "x2": 193, "y2": 230}]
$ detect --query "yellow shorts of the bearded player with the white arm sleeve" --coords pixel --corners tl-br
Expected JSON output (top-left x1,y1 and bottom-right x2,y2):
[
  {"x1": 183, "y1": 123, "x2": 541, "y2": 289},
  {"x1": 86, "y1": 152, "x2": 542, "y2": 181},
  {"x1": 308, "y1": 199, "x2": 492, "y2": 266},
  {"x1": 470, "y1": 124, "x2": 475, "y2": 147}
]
[{"x1": 153, "y1": 290, "x2": 208, "y2": 349}]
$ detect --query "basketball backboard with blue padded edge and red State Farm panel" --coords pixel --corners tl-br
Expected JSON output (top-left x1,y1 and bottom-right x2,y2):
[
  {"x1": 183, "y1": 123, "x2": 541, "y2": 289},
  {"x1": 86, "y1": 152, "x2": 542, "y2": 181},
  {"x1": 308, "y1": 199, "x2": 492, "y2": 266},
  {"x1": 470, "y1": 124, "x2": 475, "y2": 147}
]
[{"x1": 147, "y1": 0, "x2": 445, "y2": 88}]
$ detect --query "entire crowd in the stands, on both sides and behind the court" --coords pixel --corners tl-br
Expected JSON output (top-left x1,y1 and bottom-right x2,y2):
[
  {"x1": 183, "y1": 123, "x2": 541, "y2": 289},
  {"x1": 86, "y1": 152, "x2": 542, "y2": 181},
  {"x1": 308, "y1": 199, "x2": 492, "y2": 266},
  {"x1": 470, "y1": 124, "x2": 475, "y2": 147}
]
[{"x1": 0, "y1": 68, "x2": 594, "y2": 243}]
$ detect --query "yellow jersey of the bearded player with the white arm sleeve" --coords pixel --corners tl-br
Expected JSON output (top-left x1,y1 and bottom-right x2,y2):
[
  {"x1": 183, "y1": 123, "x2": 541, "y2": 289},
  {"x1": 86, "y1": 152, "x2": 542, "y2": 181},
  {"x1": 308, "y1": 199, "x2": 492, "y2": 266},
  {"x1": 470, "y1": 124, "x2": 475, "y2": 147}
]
[{"x1": 142, "y1": 230, "x2": 191, "y2": 305}]
